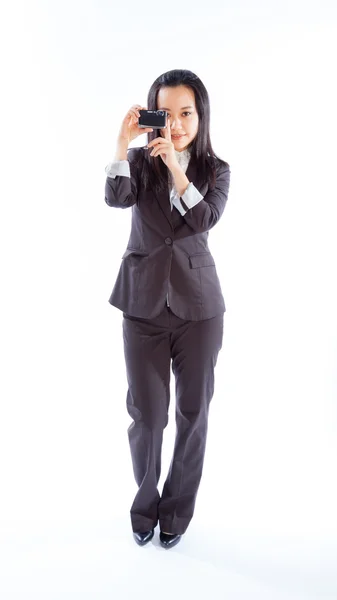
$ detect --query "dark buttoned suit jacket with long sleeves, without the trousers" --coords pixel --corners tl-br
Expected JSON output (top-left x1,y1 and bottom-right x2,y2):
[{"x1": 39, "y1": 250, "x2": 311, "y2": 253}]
[{"x1": 105, "y1": 147, "x2": 230, "y2": 321}]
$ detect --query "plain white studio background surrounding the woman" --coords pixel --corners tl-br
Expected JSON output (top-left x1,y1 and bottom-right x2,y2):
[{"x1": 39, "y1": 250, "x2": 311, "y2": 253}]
[{"x1": 0, "y1": 0, "x2": 337, "y2": 600}]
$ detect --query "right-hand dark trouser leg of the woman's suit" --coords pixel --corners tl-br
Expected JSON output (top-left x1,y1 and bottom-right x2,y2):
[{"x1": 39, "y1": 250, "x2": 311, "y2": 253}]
[{"x1": 159, "y1": 313, "x2": 224, "y2": 534}]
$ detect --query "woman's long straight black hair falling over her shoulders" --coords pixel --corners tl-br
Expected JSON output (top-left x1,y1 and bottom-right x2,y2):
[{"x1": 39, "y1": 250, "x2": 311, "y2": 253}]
[{"x1": 135, "y1": 69, "x2": 227, "y2": 193}]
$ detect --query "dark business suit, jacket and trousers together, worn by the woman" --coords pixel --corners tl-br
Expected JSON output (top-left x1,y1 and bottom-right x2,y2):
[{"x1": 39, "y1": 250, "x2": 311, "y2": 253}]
[{"x1": 105, "y1": 148, "x2": 230, "y2": 533}]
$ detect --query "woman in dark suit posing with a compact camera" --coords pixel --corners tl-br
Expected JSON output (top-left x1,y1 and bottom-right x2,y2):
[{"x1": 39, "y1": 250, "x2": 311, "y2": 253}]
[{"x1": 105, "y1": 70, "x2": 230, "y2": 548}]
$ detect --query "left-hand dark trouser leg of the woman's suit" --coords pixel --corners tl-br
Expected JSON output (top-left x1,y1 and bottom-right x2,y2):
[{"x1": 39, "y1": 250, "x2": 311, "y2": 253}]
[{"x1": 123, "y1": 310, "x2": 171, "y2": 531}]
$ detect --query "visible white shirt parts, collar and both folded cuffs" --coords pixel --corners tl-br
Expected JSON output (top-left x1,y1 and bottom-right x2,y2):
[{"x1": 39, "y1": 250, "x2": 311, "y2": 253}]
[{"x1": 105, "y1": 148, "x2": 203, "y2": 216}]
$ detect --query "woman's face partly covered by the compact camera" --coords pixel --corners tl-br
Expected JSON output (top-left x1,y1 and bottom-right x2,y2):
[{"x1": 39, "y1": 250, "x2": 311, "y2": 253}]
[{"x1": 157, "y1": 85, "x2": 199, "y2": 152}]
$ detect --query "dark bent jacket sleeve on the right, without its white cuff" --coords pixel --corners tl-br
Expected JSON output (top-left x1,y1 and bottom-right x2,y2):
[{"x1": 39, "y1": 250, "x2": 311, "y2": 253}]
[{"x1": 181, "y1": 163, "x2": 230, "y2": 233}]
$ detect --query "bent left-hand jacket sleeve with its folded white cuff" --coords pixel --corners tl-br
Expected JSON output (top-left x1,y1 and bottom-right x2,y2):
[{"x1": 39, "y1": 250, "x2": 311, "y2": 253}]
[{"x1": 105, "y1": 148, "x2": 139, "y2": 208}]
